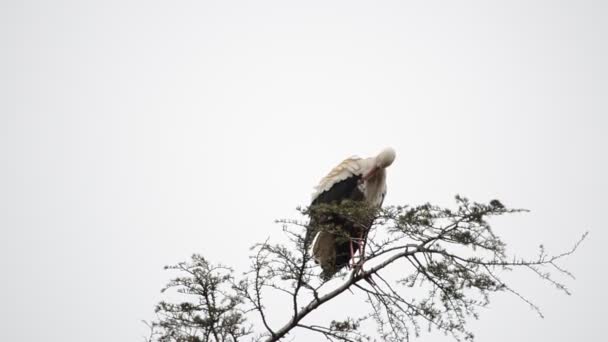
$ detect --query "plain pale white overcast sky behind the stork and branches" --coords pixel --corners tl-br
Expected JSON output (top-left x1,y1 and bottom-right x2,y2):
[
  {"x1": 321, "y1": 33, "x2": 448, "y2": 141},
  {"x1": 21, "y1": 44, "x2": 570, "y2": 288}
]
[{"x1": 0, "y1": 1, "x2": 608, "y2": 342}]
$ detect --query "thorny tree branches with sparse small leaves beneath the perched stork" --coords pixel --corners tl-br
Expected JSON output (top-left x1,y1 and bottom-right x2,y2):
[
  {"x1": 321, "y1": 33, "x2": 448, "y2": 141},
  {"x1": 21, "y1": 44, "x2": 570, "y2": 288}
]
[{"x1": 148, "y1": 196, "x2": 587, "y2": 342}]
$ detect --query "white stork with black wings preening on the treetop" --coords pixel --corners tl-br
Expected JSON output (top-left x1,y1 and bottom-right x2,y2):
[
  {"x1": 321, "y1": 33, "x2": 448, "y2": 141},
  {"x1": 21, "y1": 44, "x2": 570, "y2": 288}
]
[{"x1": 304, "y1": 147, "x2": 396, "y2": 280}]
